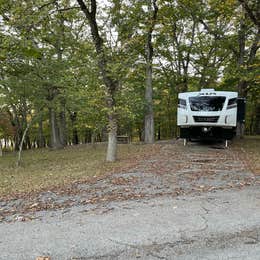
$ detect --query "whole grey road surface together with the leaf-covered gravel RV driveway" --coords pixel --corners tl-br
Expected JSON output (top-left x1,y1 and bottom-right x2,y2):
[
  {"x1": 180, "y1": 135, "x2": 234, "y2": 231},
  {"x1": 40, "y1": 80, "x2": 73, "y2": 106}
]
[{"x1": 0, "y1": 142, "x2": 260, "y2": 260}]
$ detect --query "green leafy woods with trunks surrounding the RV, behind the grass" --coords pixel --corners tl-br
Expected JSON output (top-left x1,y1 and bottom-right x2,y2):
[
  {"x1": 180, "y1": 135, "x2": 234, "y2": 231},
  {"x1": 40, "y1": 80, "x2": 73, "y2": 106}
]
[{"x1": 0, "y1": 0, "x2": 260, "y2": 161}]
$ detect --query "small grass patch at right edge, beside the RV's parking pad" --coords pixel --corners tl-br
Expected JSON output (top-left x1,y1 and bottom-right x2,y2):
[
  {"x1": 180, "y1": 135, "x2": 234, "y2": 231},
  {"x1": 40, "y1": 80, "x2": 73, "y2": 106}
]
[{"x1": 235, "y1": 136, "x2": 260, "y2": 175}]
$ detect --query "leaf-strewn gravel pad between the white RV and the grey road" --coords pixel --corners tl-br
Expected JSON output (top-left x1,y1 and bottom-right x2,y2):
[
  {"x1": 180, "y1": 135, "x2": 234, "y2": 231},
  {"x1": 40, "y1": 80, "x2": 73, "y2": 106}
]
[{"x1": 0, "y1": 141, "x2": 260, "y2": 222}]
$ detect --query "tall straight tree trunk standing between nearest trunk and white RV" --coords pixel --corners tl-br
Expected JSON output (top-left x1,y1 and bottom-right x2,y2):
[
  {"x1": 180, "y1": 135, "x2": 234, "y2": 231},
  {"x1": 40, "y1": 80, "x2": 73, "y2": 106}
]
[{"x1": 144, "y1": 0, "x2": 158, "y2": 144}]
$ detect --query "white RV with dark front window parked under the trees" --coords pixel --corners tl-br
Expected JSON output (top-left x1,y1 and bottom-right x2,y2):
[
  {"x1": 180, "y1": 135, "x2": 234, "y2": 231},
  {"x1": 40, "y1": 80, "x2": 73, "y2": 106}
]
[{"x1": 177, "y1": 89, "x2": 245, "y2": 144}]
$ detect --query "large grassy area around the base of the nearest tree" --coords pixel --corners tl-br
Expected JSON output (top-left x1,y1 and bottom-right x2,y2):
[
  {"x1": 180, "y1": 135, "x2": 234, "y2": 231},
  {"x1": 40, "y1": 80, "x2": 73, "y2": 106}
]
[{"x1": 0, "y1": 144, "x2": 149, "y2": 197}]
